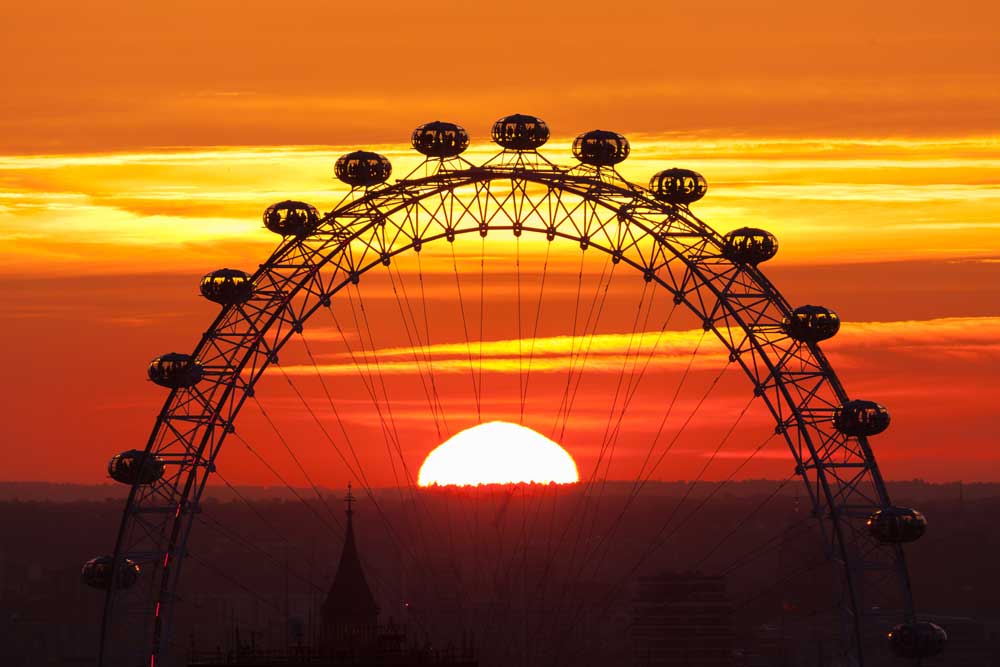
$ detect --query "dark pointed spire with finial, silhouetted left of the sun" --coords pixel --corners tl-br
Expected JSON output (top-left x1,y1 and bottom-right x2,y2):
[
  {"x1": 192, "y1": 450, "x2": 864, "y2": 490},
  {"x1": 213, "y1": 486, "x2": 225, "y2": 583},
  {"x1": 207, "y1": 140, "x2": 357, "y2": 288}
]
[{"x1": 321, "y1": 484, "x2": 378, "y2": 648}]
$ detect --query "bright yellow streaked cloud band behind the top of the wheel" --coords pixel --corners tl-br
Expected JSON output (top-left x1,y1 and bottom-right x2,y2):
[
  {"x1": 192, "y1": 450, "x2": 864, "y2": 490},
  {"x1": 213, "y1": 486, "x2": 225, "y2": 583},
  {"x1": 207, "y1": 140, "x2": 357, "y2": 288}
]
[{"x1": 0, "y1": 132, "x2": 1000, "y2": 275}]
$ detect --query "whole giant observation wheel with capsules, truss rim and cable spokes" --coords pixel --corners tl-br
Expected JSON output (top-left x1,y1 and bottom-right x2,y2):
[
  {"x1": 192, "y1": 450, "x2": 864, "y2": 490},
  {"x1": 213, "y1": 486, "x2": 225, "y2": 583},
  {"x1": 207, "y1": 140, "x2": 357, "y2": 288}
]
[{"x1": 83, "y1": 114, "x2": 944, "y2": 667}]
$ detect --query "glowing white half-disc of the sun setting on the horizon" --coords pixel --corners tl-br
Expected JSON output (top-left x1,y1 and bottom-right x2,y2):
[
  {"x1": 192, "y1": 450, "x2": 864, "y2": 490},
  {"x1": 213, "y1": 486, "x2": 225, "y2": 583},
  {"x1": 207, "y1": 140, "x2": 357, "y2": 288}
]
[{"x1": 418, "y1": 421, "x2": 580, "y2": 486}]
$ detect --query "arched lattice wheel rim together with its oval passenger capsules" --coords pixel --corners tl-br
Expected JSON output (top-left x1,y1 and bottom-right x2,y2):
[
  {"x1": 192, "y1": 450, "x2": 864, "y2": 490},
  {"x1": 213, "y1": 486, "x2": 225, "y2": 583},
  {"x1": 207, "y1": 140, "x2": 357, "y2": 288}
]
[{"x1": 83, "y1": 114, "x2": 946, "y2": 667}]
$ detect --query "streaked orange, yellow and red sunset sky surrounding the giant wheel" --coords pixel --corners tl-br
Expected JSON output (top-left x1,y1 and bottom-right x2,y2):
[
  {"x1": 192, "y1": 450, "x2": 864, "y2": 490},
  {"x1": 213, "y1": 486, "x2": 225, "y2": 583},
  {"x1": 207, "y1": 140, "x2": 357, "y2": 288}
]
[{"x1": 0, "y1": 0, "x2": 1000, "y2": 485}]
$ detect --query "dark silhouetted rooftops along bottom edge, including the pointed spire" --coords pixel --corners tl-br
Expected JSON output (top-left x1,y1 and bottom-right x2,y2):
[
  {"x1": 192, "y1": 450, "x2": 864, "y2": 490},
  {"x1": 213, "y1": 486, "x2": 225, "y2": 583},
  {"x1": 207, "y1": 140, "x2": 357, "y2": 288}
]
[{"x1": 189, "y1": 487, "x2": 478, "y2": 667}]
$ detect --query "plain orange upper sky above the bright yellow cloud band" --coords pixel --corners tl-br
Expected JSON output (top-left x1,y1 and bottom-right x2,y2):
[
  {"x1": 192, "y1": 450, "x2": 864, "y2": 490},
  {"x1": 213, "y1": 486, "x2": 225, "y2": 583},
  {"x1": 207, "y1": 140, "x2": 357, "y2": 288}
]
[{"x1": 0, "y1": 0, "x2": 1000, "y2": 152}]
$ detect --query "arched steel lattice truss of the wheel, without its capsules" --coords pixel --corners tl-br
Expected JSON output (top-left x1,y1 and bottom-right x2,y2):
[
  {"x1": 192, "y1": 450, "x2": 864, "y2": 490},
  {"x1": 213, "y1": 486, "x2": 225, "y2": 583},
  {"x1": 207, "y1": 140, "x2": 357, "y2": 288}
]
[{"x1": 100, "y1": 151, "x2": 913, "y2": 667}]
